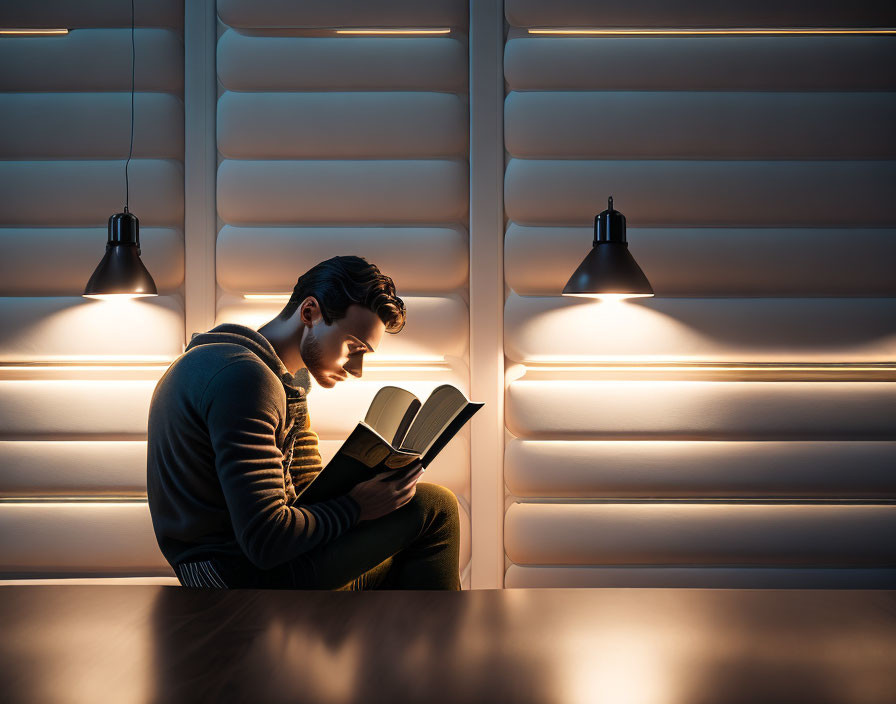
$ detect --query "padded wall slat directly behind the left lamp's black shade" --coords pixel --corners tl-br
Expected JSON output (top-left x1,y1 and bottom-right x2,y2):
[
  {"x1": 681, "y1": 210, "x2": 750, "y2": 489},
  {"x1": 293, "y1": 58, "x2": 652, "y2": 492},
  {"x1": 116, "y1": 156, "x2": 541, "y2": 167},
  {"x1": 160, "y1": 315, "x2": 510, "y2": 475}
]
[{"x1": 0, "y1": 227, "x2": 184, "y2": 296}]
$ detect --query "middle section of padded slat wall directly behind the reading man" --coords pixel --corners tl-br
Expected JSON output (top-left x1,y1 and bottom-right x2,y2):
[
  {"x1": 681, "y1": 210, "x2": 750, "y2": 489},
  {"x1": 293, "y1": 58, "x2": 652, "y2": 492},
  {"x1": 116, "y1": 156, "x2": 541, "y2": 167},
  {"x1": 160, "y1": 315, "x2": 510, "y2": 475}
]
[{"x1": 216, "y1": 0, "x2": 470, "y2": 585}]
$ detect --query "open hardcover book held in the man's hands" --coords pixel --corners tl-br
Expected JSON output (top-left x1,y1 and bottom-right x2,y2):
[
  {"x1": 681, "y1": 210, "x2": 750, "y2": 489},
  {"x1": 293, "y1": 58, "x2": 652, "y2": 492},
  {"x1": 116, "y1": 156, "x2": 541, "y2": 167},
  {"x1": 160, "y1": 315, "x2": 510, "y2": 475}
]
[{"x1": 299, "y1": 384, "x2": 485, "y2": 503}]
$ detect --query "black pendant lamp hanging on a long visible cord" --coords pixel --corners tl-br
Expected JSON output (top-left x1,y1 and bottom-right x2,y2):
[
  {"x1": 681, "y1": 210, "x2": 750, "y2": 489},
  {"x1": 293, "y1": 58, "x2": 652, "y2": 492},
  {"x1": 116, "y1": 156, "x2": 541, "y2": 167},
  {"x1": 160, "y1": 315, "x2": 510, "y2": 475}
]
[{"x1": 81, "y1": 0, "x2": 158, "y2": 298}]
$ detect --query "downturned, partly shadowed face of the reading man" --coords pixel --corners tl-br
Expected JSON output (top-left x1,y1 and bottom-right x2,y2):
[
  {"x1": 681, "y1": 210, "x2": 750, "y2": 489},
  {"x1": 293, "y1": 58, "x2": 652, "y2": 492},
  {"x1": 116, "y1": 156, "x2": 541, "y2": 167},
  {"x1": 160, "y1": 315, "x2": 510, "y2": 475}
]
[{"x1": 299, "y1": 304, "x2": 386, "y2": 389}]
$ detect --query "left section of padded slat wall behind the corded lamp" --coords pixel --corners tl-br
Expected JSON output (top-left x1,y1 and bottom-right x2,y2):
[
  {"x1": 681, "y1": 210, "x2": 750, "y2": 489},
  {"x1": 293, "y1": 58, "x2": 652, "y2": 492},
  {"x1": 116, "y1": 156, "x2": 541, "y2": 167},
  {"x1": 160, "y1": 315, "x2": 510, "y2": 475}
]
[{"x1": 0, "y1": 0, "x2": 184, "y2": 578}]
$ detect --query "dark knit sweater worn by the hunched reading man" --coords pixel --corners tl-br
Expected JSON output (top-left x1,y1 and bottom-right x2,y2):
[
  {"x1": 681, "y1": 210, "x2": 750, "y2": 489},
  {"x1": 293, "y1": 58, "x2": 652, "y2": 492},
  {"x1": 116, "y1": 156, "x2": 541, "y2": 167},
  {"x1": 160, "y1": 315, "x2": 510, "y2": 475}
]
[{"x1": 146, "y1": 323, "x2": 361, "y2": 569}]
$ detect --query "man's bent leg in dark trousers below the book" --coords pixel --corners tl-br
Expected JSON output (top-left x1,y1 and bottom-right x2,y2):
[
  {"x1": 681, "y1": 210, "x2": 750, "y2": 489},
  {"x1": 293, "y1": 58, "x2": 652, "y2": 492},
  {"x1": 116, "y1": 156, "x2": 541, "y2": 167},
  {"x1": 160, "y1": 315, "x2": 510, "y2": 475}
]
[{"x1": 288, "y1": 482, "x2": 460, "y2": 590}]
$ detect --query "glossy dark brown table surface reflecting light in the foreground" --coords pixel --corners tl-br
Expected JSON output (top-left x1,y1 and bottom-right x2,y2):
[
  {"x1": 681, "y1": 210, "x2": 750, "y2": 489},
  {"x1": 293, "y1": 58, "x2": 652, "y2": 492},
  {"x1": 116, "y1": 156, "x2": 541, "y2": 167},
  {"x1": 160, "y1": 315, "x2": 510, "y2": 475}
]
[{"x1": 0, "y1": 586, "x2": 896, "y2": 704}]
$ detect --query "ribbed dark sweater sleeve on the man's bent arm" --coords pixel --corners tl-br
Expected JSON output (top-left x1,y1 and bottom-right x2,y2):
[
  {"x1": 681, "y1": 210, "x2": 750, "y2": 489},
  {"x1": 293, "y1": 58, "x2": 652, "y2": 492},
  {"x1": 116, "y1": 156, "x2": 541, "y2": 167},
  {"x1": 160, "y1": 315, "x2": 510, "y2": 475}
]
[{"x1": 201, "y1": 360, "x2": 360, "y2": 569}]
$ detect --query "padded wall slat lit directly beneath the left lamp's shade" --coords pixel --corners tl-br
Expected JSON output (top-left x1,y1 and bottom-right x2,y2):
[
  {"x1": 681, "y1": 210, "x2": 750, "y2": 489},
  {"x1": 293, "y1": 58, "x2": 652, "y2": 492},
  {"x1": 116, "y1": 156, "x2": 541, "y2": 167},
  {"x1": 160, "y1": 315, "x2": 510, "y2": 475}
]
[{"x1": 0, "y1": 296, "x2": 184, "y2": 362}]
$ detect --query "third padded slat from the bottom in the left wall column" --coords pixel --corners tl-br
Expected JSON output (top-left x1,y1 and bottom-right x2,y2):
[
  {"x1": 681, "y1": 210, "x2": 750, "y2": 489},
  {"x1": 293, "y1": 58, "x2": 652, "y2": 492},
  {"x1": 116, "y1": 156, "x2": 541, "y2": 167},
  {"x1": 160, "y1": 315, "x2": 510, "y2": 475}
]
[{"x1": 0, "y1": 380, "x2": 156, "y2": 440}]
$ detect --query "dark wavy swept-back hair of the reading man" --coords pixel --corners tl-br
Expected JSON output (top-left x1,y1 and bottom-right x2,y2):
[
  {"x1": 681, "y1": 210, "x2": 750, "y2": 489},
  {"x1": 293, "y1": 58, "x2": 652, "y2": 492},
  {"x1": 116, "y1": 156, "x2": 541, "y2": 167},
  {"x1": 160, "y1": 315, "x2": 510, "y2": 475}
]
[{"x1": 277, "y1": 256, "x2": 405, "y2": 334}]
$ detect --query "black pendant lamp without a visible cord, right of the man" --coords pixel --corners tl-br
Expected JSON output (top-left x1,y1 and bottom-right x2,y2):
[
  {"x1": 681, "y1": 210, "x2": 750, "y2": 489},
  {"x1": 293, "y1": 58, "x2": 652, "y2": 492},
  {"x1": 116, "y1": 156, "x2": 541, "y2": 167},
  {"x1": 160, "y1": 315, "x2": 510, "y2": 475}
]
[{"x1": 562, "y1": 196, "x2": 653, "y2": 300}]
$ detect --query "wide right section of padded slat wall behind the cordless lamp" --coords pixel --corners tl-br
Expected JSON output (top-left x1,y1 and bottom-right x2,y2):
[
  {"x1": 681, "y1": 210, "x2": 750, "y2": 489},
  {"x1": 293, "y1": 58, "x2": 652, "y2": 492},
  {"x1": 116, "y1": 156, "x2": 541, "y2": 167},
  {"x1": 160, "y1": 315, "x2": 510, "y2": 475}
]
[{"x1": 504, "y1": 5, "x2": 896, "y2": 588}]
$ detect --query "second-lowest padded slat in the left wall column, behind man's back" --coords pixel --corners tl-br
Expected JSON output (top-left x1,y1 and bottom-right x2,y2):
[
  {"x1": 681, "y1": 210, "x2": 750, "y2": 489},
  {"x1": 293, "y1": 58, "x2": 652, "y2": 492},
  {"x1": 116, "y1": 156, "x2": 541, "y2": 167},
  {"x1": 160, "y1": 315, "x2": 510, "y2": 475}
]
[{"x1": 0, "y1": 440, "x2": 146, "y2": 498}]
